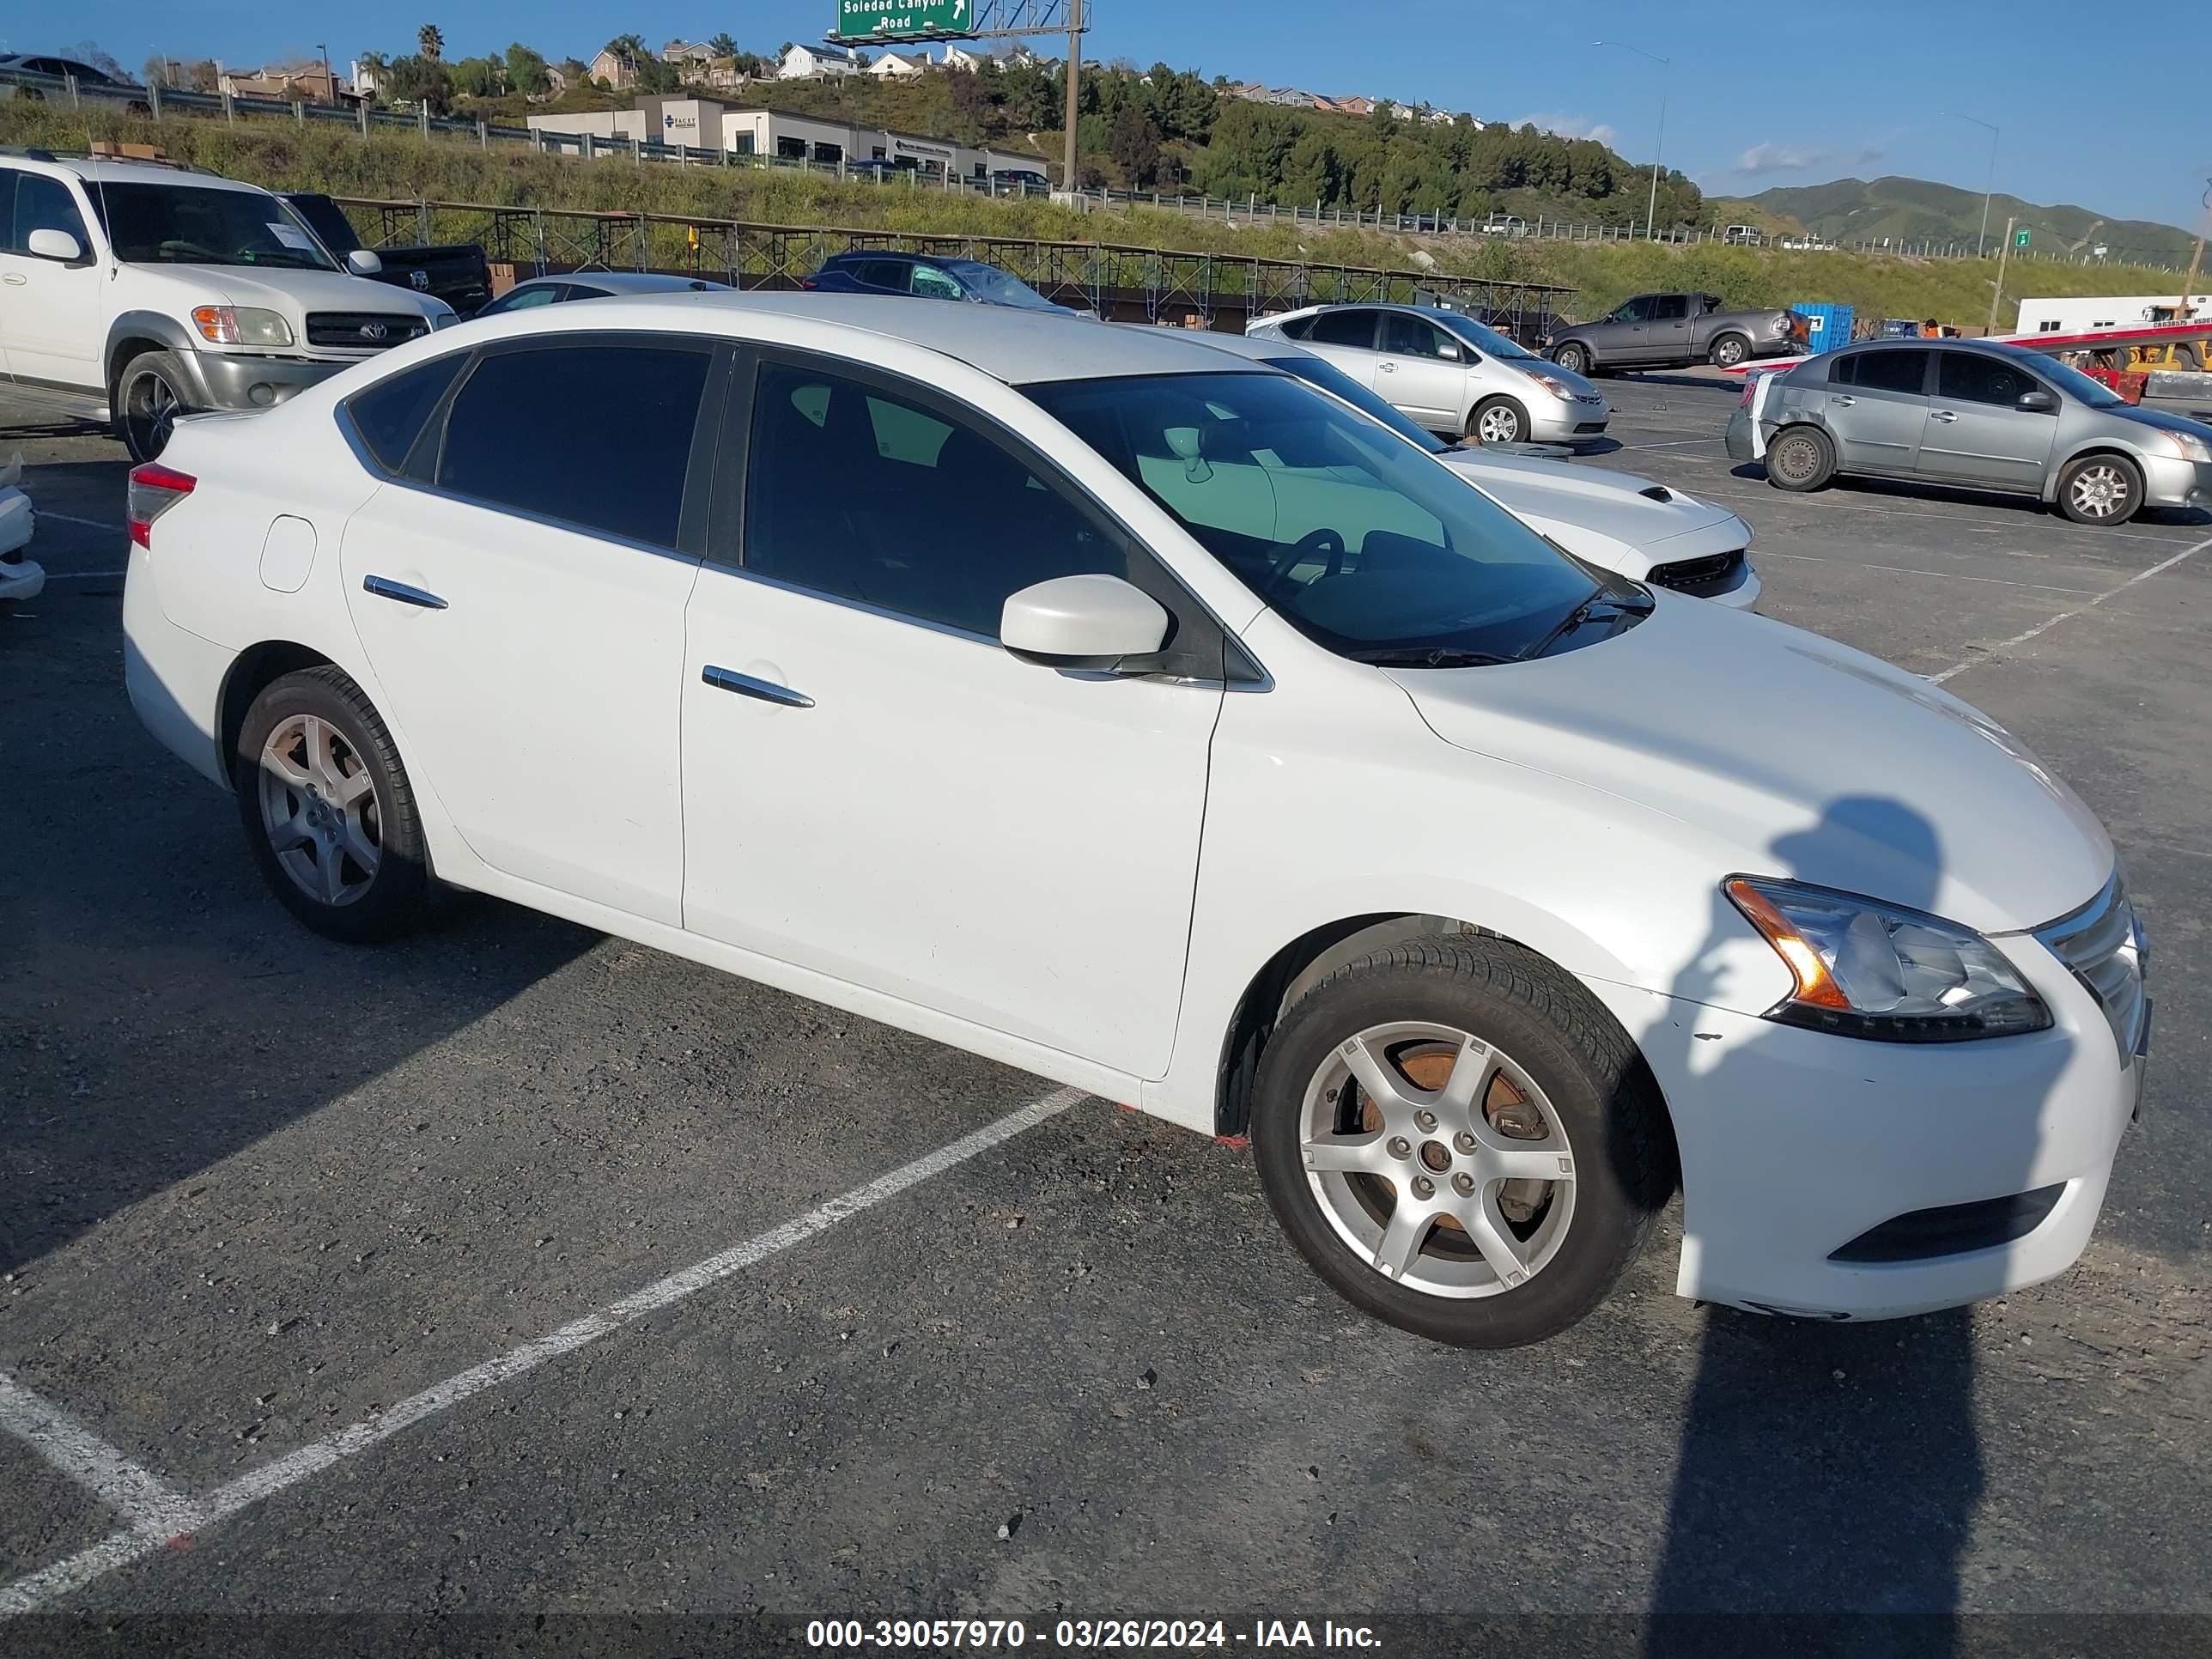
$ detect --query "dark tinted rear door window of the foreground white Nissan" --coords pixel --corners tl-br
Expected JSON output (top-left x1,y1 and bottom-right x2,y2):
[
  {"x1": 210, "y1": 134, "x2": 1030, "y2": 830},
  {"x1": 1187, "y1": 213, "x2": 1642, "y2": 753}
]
[{"x1": 438, "y1": 343, "x2": 710, "y2": 549}]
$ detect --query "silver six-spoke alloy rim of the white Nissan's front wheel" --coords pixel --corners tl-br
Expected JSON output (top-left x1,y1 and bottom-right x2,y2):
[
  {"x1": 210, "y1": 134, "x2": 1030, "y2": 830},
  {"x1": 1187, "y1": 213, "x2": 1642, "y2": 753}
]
[{"x1": 1298, "y1": 1020, "x2": 1575, "y2": 1298}]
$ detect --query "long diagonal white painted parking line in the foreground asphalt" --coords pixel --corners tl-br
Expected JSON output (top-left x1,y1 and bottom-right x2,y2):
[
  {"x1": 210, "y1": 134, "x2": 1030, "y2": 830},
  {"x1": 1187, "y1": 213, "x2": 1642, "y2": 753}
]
[{"x1": 0, "y1": 1088, "x2": 1086, "y2": 1620}]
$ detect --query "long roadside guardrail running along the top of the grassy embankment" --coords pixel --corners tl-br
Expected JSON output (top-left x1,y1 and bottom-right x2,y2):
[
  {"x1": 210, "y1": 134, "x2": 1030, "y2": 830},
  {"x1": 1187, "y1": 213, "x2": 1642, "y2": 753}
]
[{"x1": 0, "y1": 70, "x2": 2179, "y2": 270}]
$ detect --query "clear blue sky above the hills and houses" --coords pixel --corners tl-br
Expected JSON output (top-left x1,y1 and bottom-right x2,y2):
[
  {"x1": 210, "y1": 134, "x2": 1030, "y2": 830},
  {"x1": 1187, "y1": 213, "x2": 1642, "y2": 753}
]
[{"x1": 21, "y1": 0, "x2": 2212, "y2": 228}]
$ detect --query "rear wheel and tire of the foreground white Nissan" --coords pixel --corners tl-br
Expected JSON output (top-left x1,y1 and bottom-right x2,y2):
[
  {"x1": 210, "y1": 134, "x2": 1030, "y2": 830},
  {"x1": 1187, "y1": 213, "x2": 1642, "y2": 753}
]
[{"x1": 230, "y1": 664, "x2": 434, "y2": 945}]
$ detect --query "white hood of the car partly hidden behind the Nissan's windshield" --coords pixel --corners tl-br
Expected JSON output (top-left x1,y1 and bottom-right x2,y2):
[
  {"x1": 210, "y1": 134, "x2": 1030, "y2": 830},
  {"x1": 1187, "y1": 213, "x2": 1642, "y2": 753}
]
[{"x1": 1437, "y1": 447, "x2": 1752, "y2": 580}]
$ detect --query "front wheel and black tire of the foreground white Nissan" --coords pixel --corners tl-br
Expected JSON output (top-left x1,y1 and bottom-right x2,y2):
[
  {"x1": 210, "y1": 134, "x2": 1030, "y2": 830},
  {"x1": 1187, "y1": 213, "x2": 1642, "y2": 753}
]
[{"x1": 1252, "y1": 933, "x2": 1674, "y2": 1347}]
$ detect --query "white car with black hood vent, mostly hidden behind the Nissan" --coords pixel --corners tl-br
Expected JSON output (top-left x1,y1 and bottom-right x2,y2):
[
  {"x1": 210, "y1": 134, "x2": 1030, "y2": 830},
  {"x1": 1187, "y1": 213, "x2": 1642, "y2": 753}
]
[{"x1": 1199, "y1": 334, "x2": 1759, "y2": 611}]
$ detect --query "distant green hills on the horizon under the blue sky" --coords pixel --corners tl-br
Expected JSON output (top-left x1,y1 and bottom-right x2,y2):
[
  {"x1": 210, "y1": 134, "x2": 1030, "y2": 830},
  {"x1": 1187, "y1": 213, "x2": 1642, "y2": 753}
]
[{"x1": 1745, "y1": 179, "x2": 2197, "y2": 268}]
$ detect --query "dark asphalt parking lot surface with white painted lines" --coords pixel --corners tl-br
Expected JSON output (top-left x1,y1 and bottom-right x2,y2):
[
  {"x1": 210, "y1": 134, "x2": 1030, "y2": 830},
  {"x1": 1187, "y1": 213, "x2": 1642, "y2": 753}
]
[{"x1": 0, "y1": 374, "x2": 2212, "y2": 1652}]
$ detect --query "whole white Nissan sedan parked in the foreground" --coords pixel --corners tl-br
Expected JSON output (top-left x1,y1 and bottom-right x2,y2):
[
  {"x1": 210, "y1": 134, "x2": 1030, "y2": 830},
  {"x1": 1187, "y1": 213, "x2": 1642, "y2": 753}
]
[{"x1": 124, "y1": 295, "x2": 2148, "y2": 1345}]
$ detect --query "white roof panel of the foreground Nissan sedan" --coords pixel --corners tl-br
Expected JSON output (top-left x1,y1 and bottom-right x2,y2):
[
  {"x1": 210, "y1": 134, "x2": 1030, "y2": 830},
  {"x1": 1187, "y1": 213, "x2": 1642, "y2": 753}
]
[{"x1": 471, "y1": 289, "x2": 1261, "y2": 385}]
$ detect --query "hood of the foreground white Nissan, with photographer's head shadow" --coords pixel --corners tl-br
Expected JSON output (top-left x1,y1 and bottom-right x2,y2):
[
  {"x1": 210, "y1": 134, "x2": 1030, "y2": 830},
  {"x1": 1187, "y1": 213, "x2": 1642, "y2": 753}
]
[{"x1": 1387, "y1": 592, "x2": 2112, "y2": 933}]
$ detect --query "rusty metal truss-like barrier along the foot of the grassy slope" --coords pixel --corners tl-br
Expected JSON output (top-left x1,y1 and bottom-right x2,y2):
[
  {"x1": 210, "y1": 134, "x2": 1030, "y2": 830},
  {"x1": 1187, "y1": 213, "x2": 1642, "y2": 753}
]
[{"x1": 323, "y1": 197, "x2": 1575, "y2": 338}]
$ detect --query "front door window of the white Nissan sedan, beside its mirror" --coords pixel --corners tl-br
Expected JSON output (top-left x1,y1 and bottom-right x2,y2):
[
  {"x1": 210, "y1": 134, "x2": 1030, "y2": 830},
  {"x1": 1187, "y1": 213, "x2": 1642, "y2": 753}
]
[{"x1": 744, "y1": 362, "x2": 1128, "y2": 639}]
